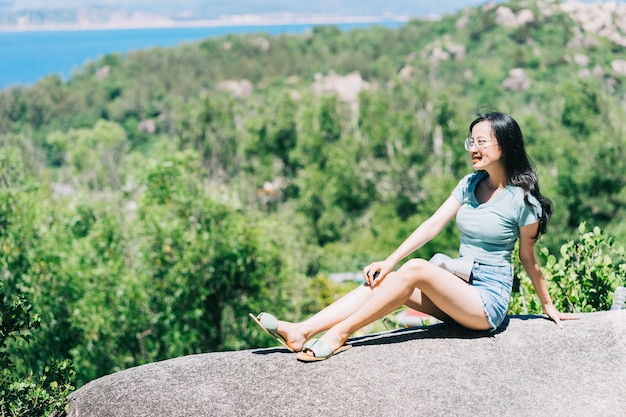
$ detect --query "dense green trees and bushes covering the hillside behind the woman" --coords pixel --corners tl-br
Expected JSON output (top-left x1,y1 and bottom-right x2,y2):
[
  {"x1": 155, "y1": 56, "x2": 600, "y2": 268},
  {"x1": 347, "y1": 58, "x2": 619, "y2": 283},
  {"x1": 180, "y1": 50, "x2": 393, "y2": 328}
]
[{"x1": 0, "y1": 2, "x2": 626, "y2": 410}]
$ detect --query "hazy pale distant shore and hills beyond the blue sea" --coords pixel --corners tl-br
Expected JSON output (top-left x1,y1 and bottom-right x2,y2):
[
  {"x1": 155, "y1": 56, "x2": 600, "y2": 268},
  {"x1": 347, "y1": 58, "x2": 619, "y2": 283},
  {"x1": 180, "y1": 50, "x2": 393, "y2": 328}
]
[{"x1": 0, "y1": 0, "x2": 508, "y2": 30}]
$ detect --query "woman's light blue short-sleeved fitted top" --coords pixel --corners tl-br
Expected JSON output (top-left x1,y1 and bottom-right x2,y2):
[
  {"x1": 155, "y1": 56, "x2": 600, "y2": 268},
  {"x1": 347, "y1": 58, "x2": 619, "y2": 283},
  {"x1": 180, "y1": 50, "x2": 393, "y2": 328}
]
[{"x1": 452, "y1": 171, "x2": 541, "y2": 265}]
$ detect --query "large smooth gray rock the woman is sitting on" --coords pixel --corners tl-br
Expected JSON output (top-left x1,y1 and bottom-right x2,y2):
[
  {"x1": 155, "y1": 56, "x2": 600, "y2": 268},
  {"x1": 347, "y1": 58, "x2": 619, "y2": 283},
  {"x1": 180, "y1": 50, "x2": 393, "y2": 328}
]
[{"x1": 68, "y1": 310, "x2": 626, "y2": 417}]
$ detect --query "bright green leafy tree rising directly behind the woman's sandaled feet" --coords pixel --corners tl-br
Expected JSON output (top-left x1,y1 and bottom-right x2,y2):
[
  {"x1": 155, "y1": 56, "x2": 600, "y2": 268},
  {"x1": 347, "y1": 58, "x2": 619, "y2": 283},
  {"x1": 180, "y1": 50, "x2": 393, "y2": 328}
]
[{"x1": 139, "y1": 152, "x2": 292, "y2": 358}]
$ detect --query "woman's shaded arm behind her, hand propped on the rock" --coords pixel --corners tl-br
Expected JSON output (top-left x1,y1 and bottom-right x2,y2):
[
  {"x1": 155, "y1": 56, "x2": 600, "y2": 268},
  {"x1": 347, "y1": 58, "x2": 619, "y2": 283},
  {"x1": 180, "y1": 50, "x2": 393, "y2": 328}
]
[{"x1": 519, "y1": 222, "x2": 578, "y2": 327}]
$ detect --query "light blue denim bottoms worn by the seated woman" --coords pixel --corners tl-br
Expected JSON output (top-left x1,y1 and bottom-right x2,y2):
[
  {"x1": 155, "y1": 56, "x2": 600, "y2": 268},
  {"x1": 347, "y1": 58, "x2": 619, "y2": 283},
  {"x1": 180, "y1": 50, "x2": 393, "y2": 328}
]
[{"x1": 470, "y1": 263, "x2": 513, "y2": 331}]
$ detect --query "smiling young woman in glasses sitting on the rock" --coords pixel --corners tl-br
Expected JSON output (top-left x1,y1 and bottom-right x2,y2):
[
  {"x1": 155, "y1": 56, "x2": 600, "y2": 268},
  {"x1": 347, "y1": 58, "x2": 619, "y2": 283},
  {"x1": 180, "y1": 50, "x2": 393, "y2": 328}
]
[{"x1": 251, "y1": 112, "x2": 575, "y2": 361}]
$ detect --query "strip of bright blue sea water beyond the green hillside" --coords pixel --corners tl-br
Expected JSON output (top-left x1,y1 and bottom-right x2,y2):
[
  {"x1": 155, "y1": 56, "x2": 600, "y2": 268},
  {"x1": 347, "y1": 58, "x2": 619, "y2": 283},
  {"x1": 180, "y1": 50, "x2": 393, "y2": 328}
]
[{"x1": 0, "y1": 22, "x2": 402, "y2": 89}]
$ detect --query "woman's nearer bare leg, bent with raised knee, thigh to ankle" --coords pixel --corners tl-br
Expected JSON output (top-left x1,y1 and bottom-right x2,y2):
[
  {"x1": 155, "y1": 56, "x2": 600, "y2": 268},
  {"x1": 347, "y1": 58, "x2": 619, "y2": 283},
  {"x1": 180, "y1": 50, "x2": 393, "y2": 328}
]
[{"x1": 308, "y1": 259, "x2": 489, "y2": 347}]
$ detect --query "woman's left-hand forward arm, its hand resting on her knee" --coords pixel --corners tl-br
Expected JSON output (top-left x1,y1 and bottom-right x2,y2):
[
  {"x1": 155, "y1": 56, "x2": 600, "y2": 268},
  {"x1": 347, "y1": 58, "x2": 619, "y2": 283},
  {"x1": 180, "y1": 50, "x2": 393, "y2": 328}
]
[{"x1": 363, "y1": 196, "x2": 461, "y2": 283}]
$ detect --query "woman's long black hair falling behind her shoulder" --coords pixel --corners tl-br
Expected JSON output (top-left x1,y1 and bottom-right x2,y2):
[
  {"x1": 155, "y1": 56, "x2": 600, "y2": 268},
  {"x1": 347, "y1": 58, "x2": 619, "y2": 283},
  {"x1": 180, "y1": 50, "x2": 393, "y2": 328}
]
[{"x1": 469, "y1": 112, "x2": 553, "y2": 234}]
